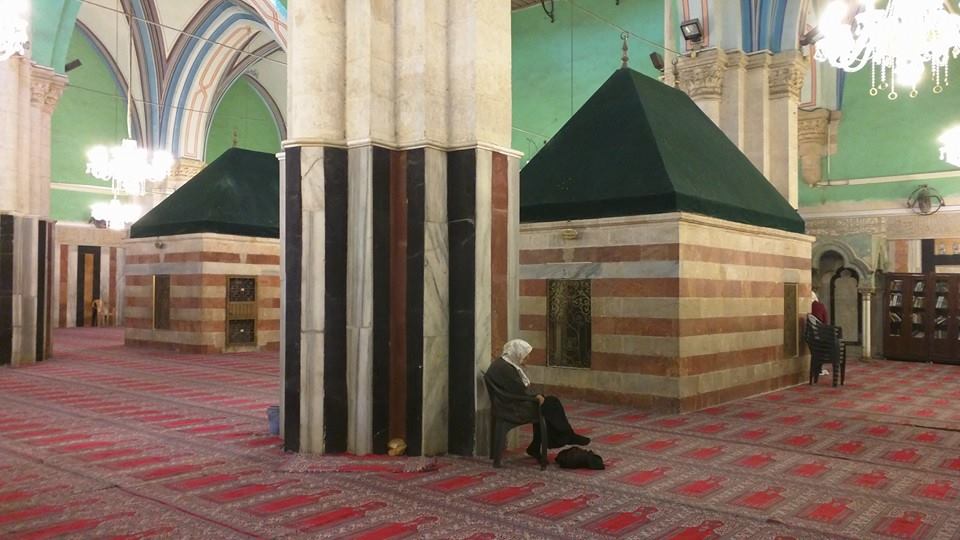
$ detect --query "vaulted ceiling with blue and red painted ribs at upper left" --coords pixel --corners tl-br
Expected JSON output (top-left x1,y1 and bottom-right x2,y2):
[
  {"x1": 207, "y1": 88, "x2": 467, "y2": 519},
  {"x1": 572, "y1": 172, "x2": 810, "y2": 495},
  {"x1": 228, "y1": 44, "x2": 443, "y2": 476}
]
[{"x1": 48, "y1": 0, "x2": 287, "y2": 159}]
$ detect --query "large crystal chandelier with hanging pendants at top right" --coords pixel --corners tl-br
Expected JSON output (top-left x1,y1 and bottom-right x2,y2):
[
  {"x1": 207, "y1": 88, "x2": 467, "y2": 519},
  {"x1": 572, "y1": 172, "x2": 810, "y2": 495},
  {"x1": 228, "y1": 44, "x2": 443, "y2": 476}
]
[{"x1": 815, "y1": 0, "x2": 960, "y2": 99}]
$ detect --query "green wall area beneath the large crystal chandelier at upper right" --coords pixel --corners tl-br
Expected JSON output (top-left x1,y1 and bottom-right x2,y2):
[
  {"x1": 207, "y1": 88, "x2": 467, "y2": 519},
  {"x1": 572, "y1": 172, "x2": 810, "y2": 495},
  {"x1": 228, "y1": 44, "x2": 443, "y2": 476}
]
[{"x1": 800, "y1": 61, "x2": 960, "y2": 207}]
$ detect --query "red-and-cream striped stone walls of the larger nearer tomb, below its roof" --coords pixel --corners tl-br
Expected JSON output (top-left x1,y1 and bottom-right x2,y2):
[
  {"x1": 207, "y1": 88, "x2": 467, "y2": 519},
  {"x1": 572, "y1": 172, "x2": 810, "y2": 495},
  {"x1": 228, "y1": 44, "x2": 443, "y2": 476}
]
[{"x1": 520, "y1": 214, "x2": 813, "y2": 411}]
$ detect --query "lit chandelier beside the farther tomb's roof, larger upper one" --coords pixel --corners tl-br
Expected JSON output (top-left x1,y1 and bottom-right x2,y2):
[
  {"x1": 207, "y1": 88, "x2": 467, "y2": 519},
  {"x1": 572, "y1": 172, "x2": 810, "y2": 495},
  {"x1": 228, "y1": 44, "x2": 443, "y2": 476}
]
[{"x1": 87, "y1": 138, "x2": 173, "y2": 196}]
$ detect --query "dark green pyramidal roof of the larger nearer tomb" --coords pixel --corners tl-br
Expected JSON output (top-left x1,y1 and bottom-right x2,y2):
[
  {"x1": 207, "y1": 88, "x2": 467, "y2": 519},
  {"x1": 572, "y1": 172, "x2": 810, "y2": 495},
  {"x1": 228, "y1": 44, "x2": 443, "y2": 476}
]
[{"x1": 520, "y1": 69, "x2": 805, "y2": 233}]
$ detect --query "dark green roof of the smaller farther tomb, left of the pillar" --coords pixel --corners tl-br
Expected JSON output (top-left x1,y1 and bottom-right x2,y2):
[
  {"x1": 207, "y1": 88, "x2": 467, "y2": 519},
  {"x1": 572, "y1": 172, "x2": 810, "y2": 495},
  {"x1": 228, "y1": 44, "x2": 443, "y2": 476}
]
[{"x1": 130, "y1": 148, "x2": 280, "y2": 238}]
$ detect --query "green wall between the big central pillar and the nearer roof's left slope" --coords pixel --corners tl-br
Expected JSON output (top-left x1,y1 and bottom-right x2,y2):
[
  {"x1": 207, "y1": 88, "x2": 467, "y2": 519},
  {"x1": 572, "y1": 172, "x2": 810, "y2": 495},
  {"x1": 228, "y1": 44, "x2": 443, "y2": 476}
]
[{"x1": 512, "y1": 0, "x2": 663, "y2": 164}]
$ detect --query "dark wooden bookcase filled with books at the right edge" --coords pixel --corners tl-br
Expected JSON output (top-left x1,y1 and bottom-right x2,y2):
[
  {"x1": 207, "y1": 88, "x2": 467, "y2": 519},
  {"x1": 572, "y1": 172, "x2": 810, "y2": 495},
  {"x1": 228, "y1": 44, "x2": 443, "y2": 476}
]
[{"x1": 883, "y1": 274, "x2": 960, "y2": 363}]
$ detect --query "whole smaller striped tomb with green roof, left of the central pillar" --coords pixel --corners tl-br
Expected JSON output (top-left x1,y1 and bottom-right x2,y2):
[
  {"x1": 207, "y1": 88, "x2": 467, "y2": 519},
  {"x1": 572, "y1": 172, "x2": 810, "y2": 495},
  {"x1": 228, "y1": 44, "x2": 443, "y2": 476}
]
[{"x1": 124, "y1": 148, "x2": 280, "y2": 353}]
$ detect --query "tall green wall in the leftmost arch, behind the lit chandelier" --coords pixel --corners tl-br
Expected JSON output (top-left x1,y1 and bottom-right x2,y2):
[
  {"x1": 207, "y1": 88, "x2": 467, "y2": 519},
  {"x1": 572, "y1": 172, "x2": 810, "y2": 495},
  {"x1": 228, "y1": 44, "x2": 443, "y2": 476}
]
[{"x1": 50, "y1": 26, "x2": 127, "y2": 222}]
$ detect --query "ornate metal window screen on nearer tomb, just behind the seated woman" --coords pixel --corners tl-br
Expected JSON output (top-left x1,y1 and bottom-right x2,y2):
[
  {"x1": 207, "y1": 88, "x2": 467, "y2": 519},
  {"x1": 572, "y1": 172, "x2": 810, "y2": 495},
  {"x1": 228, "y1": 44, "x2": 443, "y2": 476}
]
[{"x1": 547, "y1": 279, "x2": 590, "y2": 368}]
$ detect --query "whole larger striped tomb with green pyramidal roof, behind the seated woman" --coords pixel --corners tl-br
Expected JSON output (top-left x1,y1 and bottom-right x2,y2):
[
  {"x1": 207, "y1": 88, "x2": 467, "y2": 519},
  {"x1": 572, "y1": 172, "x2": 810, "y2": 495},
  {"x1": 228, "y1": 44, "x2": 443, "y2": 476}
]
[{"x1": 519, "y1": 68, "x2": 814, "y2": 411}]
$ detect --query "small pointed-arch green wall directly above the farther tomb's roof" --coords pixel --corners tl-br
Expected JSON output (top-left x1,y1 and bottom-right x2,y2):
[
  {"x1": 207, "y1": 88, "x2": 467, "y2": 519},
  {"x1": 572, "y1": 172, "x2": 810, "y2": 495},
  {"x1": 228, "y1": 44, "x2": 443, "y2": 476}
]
[{"x1": 205, "y1": 77, "x2": 280, "y2": 163}]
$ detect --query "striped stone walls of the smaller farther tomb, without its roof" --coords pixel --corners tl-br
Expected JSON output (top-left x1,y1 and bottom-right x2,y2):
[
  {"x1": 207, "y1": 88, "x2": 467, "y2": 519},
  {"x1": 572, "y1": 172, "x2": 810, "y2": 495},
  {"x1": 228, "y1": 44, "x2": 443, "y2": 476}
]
[{"x1": 124, "y1": 233, "x2": 280, "y2": 353}]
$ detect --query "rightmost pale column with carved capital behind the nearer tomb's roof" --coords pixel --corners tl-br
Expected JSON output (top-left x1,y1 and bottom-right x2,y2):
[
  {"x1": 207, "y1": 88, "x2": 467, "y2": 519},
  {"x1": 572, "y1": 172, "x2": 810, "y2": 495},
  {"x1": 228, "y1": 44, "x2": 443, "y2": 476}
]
[{"x1": 767, "y1": 51, "x2": 809, "y2": 208}]
